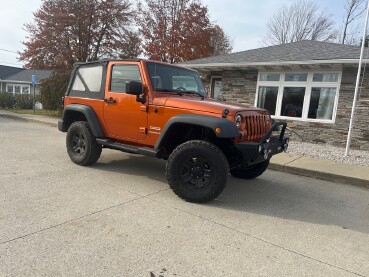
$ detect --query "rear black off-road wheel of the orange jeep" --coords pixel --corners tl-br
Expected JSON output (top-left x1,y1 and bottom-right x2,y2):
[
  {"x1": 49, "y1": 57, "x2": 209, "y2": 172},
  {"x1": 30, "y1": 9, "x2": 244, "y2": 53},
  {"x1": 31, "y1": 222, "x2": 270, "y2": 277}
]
[{"x1": 66, "y1": 121, "x2": 102, "y2": 165}]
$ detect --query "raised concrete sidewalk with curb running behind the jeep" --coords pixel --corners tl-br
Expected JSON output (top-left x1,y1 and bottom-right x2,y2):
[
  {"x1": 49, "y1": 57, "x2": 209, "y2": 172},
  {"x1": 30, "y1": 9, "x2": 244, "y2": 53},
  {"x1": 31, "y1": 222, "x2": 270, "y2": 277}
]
[{"x1": 0, "y1": 110, "x2": 369, "y2": 189}]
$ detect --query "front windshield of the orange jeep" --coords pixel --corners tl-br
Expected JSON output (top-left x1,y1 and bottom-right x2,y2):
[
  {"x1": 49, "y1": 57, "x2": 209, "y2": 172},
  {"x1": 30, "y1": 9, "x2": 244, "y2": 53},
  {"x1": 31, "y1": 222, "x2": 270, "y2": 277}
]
[{"x1": 147, "y1": 62, "x2": 206, "y2": 97}]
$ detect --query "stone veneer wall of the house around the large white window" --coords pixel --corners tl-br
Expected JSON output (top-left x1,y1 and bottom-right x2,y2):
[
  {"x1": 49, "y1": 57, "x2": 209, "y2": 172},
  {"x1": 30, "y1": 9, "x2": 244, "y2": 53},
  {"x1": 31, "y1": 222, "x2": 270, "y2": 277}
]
[{"x1": 207, "y1": 67, "x2": 369, "y2": 150}]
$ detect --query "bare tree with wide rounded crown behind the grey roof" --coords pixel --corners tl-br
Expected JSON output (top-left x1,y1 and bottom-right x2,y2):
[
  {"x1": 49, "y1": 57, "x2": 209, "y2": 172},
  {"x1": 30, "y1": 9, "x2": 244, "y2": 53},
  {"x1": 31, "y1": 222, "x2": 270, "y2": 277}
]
[{"x1": 264, "y1": 1, "x2": 337, "y2": 45}]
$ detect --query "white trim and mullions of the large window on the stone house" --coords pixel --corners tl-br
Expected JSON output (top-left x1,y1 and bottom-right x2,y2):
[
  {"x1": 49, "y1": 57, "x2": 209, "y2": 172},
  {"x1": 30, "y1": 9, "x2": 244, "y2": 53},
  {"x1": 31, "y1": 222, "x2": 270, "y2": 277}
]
[{"x1": 254, "y1": 69, "x2": 342, "y2": 124}]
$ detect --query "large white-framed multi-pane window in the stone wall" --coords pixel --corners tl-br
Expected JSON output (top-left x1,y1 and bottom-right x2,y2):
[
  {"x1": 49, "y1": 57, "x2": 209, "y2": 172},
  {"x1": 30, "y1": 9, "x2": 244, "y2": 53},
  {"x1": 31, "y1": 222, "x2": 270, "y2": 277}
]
[{"x1": 255, "y1": 72, "x2": 341, "y2": 123}]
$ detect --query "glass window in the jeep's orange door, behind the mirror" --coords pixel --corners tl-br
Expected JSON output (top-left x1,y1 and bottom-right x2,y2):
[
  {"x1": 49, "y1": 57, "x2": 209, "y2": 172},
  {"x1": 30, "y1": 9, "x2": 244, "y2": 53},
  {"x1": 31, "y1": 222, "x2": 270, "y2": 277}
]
[{"x1": 110, "y1": 65, "x2": 142, "y2": 92}]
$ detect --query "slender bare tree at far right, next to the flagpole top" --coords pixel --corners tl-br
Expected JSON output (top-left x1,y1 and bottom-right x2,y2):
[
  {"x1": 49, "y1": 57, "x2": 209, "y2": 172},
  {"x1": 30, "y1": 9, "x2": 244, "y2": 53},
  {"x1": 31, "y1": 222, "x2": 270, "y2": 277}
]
[{"x1": 341, "y1": 0, "x2": 366, "y2": 44}]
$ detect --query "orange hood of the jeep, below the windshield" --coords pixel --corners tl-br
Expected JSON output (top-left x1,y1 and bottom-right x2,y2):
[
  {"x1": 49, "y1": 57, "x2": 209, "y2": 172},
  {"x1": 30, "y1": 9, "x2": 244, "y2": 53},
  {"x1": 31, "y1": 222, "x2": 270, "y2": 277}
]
[{"x1": 162, "y1": 96, "x2": 265, "y2": 115}]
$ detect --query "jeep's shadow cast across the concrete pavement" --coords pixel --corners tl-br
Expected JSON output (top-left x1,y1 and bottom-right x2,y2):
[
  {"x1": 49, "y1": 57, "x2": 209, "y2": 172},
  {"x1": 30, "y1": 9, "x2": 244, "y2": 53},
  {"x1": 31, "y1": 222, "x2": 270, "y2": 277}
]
[{"x1": 89, "y1": 152, "x2": 369, "y2": 233}]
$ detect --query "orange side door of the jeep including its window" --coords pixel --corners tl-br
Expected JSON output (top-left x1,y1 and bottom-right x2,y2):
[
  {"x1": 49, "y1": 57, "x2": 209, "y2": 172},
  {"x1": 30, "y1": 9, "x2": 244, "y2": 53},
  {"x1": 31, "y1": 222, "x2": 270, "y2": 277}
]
[{"x1": 104, "y1": 62, "x2": 147, "y2": 142}]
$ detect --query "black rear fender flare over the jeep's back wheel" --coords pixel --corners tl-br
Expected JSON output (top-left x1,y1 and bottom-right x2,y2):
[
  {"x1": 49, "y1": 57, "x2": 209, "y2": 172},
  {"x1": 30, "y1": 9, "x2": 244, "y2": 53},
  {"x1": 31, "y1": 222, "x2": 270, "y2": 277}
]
[{"x1": 58, "y1": 104, "x2": 104, "y2": 138}]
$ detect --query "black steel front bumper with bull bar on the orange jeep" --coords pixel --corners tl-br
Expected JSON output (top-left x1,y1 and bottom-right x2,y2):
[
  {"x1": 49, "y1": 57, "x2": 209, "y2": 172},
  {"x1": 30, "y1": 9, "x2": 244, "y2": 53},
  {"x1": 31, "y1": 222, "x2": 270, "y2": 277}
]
[{"x1": 235, "y1": 122, "x2": 289, "y2": 168}]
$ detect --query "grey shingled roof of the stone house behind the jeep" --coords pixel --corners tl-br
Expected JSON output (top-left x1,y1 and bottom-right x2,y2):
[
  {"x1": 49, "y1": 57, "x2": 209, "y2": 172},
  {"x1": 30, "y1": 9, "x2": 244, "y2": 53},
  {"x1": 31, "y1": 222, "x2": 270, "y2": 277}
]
[{"x1": 181, "y1": 40, "x2": 360, "y2": 67}]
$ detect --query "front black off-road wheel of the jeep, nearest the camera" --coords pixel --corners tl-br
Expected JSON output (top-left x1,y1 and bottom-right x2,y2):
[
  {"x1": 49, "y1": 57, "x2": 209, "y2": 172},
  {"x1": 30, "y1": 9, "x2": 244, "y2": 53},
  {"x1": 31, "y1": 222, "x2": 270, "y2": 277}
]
[{"x1": 166, "y1": 140, "x2": 229, "y2": 203}]
